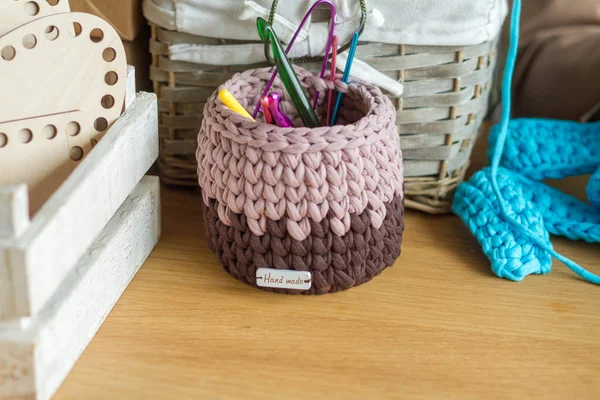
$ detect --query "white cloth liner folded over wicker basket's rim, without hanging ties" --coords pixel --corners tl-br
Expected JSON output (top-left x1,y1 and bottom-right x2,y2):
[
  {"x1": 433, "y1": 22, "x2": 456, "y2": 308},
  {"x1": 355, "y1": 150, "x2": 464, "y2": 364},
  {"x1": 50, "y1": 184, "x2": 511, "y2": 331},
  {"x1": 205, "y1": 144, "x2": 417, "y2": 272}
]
[{"x1": 145, "y1": 0, "x2": 508, "y2": 47}]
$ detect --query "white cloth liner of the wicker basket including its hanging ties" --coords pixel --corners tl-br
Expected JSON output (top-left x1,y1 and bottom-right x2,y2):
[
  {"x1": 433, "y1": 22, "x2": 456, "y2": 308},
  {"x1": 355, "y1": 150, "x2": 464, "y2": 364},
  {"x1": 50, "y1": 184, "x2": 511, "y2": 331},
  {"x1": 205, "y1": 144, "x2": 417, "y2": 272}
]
[{"x1": 144, "y1": 0, "x2": 508, "y2": 95}]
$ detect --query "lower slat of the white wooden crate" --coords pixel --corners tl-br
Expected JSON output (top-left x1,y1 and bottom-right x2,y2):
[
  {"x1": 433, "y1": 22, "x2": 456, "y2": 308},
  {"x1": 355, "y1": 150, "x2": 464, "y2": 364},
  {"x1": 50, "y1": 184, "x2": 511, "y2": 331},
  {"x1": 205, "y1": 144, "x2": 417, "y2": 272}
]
[{"x1": 0, "y1": 177, "x2": 160, "y2": 400}]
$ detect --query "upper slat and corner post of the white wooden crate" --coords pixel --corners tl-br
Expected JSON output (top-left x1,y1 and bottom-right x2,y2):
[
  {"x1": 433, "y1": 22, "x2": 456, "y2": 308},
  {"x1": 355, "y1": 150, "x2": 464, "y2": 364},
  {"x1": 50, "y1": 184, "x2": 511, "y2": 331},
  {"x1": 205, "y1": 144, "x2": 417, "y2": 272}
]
[{"x1": 0, "y1": 69, "x2": 158, "y2": 321}]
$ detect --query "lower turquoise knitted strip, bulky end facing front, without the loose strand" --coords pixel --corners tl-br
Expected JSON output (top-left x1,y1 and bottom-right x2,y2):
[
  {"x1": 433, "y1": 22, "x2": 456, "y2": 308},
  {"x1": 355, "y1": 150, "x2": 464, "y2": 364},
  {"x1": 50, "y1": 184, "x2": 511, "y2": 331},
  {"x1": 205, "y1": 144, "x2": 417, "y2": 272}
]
[{"x1": 454, "y1": 168, "x2": 600, "y2": 256}]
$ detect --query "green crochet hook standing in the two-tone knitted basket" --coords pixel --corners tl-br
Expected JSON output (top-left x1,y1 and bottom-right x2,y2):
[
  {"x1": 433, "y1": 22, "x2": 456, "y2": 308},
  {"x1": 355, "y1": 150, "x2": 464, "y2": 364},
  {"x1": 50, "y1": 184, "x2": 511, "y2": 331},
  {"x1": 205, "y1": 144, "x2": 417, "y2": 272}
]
[{"x1": 256, "y1": 17, "x2": 320, "y2": 128}]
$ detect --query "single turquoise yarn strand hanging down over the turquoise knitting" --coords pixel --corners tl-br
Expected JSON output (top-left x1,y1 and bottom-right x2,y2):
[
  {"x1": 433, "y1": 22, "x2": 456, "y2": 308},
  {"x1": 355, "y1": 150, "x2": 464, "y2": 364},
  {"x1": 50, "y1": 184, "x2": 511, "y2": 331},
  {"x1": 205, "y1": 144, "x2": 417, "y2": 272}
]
[{"x1": 490, "y1": 0, "x2": 600, "y2": 285}]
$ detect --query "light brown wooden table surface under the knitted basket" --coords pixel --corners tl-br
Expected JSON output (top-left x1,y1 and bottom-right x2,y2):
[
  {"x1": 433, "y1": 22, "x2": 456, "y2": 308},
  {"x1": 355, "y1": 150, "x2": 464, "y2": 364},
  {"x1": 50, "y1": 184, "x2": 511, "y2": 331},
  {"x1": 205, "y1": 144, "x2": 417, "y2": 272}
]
[{"x1": 55, "y1": 141, "x2": 600, "y2": 400}]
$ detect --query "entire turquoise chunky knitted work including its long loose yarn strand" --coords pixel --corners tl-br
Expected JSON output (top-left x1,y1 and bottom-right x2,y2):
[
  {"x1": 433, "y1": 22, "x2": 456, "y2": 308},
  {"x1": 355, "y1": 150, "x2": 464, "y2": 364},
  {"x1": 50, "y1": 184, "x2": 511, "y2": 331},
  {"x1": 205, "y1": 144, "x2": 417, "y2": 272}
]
[{"x1": 453, "y1": 0, "x2": 600, "y2": 284}]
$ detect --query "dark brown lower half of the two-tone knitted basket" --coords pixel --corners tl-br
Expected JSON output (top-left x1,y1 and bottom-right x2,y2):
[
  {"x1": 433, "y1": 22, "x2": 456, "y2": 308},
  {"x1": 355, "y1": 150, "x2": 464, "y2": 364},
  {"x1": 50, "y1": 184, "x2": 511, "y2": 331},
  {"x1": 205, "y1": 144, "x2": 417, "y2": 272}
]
[{"x1": 202, "y1": 197, "x2": 404, "y2": 294}]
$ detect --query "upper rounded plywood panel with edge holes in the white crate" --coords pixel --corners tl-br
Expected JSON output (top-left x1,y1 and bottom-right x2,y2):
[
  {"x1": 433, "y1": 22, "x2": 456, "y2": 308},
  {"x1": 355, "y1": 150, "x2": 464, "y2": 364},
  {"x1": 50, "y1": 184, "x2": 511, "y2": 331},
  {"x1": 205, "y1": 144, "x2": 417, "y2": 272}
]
[{"x1": 0, "y1": 13, "x2": 127, "y2": 123}]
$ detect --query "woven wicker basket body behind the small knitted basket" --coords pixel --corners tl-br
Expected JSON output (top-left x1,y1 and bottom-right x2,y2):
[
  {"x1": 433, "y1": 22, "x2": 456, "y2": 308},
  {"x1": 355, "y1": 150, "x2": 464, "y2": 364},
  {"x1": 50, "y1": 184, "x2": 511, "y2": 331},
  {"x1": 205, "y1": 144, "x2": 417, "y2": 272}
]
[{"x1": 150, "y1": 26, "x2": 496, "y2": 214}]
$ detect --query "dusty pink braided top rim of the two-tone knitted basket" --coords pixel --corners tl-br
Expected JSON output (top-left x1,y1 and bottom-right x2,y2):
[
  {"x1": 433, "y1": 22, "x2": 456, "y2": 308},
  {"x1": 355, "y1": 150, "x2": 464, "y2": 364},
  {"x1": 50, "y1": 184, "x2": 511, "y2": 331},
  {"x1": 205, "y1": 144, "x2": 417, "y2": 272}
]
[{"x1": 204, "y1": 67, "x2": 396, "y2": 154}]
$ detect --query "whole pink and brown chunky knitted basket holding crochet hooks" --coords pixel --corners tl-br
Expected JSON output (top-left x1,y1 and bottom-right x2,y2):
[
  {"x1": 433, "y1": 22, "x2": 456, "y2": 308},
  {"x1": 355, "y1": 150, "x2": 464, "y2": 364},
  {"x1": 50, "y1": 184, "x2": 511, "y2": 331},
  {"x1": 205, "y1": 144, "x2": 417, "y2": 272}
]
[{"x1": 196, "y1": 68, "x2": 404, "y2": 294}]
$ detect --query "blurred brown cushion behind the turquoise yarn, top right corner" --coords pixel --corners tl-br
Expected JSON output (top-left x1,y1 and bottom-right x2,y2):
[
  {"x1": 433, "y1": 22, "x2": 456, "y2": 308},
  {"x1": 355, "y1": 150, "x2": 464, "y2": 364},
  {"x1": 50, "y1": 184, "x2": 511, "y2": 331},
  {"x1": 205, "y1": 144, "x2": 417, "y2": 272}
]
[{"x1": 513, "y1": 0, "x2": 600, "y2": 120}]
